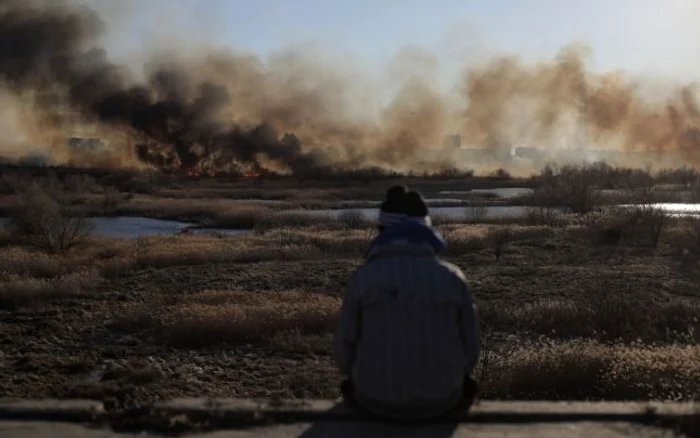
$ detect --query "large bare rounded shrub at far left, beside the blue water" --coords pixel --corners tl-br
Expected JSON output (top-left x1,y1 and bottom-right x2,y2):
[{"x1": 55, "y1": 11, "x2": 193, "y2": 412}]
[{"x1": 10, "y1": 185, "x2": 91, "y2": 251}]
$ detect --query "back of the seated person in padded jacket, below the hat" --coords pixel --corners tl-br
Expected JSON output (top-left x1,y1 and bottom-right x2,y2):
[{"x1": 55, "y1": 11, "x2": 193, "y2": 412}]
[{"x1": 336, "y1": 186, "x2": 478, "y2": 417}]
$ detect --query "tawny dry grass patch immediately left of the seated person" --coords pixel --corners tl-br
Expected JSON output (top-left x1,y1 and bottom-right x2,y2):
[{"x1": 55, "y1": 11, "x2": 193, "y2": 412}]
[{"x1": 154, "y1": 291, "x2": 340, "y2": 347}]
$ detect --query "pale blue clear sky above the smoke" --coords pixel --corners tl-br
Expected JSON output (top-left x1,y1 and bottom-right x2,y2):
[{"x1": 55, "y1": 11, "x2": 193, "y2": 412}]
[{"x1": 75, "y1": 0, "x2": 700, "y2": 81}]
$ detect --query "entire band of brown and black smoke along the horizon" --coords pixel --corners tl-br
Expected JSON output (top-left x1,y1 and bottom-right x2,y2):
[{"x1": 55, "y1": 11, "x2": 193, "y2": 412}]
[{"x1": 0, "y1": 0, "x2": 700, "y2": 174}]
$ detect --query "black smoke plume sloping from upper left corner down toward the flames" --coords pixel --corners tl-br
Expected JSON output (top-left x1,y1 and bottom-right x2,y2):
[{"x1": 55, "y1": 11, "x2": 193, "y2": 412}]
[{"x1": 0, "y1": 0, "x2": 334, "y2": 172}]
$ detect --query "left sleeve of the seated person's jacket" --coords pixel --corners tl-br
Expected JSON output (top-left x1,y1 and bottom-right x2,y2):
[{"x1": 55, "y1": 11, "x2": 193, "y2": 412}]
[{"x1": 334, "y1": 274, "x2": 361, "y2": 375}]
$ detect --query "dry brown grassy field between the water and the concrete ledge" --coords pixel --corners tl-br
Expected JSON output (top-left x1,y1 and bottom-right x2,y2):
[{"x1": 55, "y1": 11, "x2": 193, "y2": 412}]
[{"x1": 0, "y1": 164, "x2": 700, "y2": 407}]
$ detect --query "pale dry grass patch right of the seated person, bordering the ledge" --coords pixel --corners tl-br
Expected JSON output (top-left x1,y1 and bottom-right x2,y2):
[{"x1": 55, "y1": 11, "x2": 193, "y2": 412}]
[{"x1": 480, "y1": 340, "x2": 700, "y2": 400}]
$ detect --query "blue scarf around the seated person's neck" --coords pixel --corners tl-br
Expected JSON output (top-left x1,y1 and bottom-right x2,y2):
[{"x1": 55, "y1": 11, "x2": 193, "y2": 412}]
[{"x1": 365, "y1": 218, "x2": 447, "y2": 258}]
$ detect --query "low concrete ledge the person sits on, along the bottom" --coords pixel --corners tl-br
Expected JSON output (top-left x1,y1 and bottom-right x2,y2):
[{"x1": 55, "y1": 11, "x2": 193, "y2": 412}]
[{"x1": 0, "y1": 398, "x2": 700, "y2": 436}]
